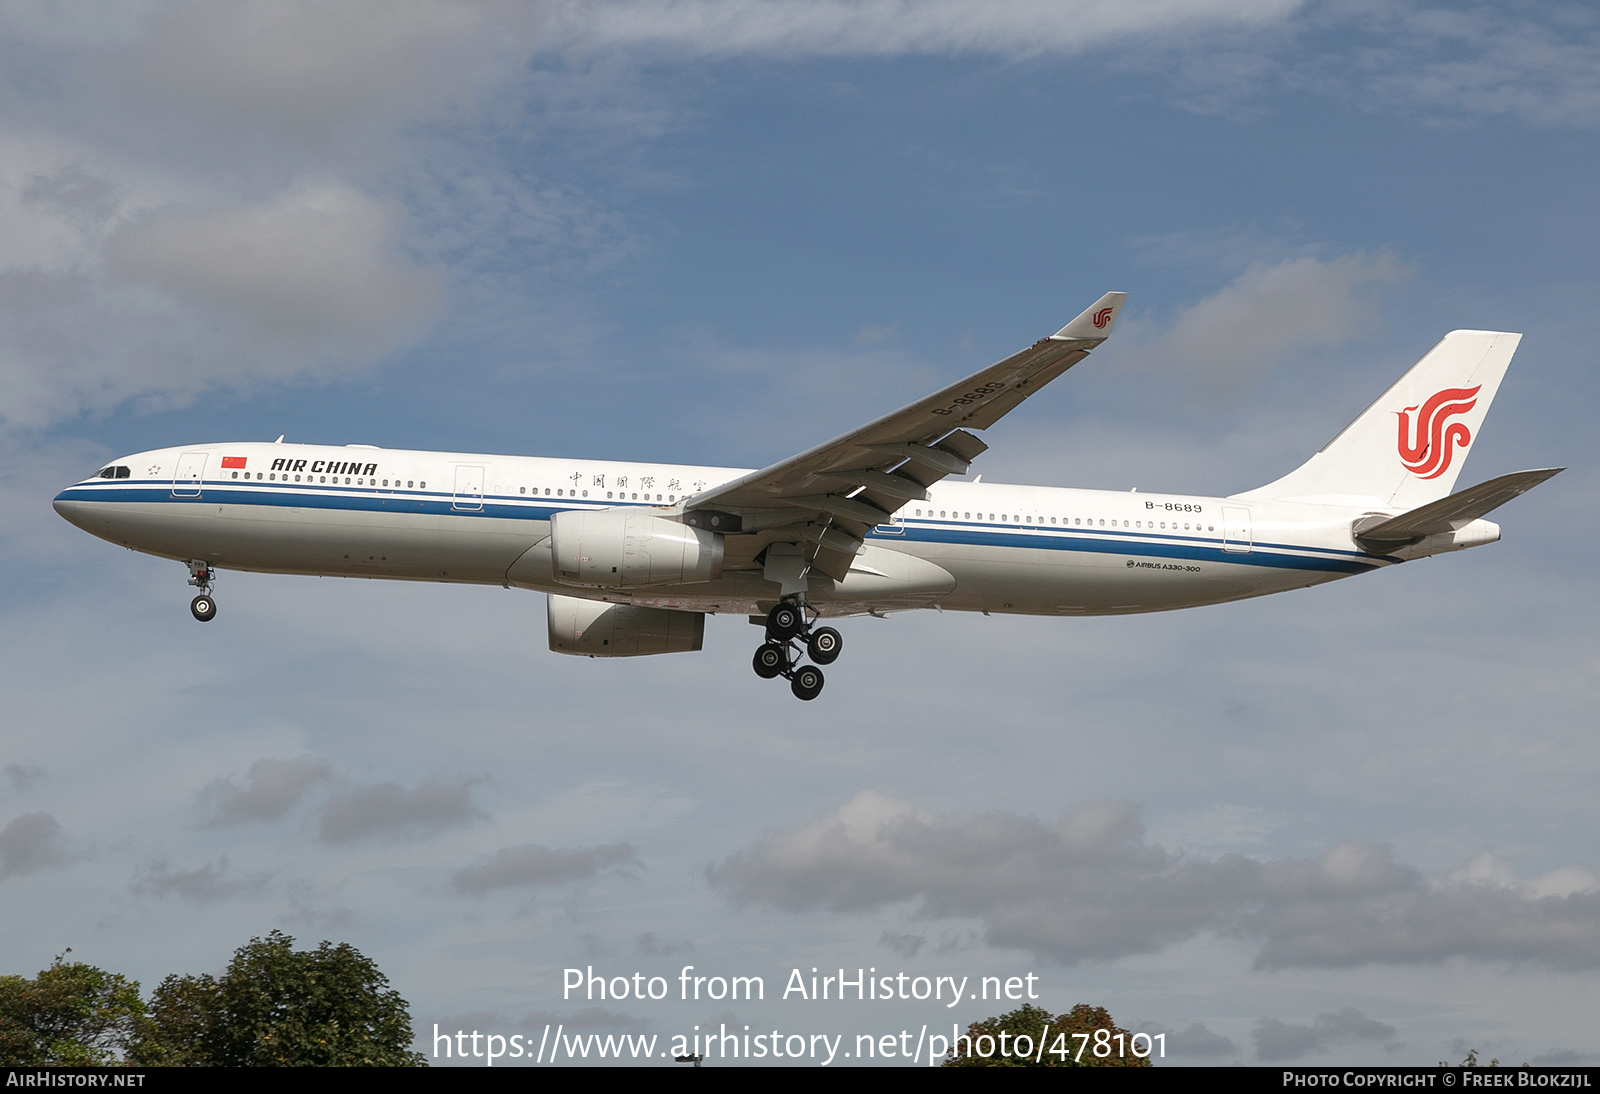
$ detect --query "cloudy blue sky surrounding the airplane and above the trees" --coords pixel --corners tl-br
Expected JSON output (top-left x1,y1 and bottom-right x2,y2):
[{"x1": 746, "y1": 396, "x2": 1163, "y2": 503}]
[{"x1": 0, "y1": 0, "x2": 1600, "y2": 1064}]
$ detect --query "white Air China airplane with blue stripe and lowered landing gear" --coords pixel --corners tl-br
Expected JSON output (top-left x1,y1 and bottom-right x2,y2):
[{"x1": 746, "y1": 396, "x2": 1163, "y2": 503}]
[{"x1": 54, "y1": 293, "x2": 1565, "y2": 701}]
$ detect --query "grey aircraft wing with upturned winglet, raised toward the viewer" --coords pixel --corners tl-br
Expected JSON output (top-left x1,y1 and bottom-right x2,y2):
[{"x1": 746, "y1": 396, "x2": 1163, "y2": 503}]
[{"x1": 683, "y1": 293, "x2": 1128, "y2": 581}]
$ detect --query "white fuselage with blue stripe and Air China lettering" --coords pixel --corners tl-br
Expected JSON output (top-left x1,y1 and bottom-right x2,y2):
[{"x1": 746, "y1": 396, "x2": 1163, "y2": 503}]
[{"x1": 54, "y1": 443, "x2": 1498, "y2": 616}]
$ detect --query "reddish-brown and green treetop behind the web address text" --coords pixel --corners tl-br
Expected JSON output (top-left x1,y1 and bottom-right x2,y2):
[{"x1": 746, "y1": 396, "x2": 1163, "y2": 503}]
[{"x1": 944, "y1": 1003, "x2": 1150, "y2": 1067}]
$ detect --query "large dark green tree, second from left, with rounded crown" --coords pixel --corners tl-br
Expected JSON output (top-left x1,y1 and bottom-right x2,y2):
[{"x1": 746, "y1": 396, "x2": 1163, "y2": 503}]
[{"x1": 133, "y1": 931, "x2": 424, "y2": 1067}]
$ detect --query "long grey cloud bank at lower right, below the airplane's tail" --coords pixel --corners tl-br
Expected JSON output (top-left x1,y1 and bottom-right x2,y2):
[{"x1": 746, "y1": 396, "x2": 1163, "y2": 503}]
[{"x1": 707, "y1": 792, "x2": 1600, "y2": 968}]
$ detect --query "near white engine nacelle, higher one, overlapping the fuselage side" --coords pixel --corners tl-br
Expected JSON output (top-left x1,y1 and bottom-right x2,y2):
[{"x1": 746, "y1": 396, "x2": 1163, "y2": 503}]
[{"x1": 550, "y1": 509, "x2": 722, "y2": 589}]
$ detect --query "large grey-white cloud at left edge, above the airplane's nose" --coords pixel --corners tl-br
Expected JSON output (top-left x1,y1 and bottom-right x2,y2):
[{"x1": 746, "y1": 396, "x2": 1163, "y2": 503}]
[{"x1": 0, "y1": 172, "x2": 443, "y2": 425}]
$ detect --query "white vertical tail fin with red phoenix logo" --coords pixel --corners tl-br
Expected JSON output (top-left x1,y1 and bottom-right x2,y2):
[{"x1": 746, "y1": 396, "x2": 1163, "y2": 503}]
[{"x1": 1238, "y1": 331, "x2": 1522, "y2": 509}]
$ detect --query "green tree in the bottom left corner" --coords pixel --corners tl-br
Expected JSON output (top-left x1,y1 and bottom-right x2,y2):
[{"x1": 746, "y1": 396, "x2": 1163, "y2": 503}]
[{"x1": 0, "y1": 950, "x2": 144, "y2": 1067}]
